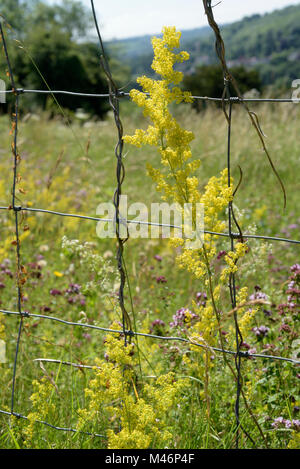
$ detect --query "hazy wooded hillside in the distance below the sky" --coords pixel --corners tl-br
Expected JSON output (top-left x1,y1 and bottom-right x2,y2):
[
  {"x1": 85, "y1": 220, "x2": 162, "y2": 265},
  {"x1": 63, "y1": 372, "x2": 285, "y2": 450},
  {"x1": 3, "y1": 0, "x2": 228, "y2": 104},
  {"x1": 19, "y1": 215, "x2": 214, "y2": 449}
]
[{"x1": 106, "y1": 4, "x2": 300, "y2": 86}]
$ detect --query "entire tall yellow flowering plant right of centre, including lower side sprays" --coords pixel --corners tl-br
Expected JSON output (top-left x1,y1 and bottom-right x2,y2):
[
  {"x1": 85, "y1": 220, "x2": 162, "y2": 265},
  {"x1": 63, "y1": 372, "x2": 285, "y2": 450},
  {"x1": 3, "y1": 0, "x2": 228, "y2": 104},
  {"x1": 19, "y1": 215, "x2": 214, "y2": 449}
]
[{"x1": 124, "y1": 27, "x2": 250, "y2": 354}]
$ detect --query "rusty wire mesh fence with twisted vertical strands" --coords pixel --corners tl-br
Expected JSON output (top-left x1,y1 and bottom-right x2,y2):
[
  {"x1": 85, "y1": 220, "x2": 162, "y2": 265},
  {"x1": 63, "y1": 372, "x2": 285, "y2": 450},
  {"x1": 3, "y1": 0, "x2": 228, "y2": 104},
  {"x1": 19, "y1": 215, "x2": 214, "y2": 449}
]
[{"x1": 0, "y1": 0, "x2": 300, "y2": 448}]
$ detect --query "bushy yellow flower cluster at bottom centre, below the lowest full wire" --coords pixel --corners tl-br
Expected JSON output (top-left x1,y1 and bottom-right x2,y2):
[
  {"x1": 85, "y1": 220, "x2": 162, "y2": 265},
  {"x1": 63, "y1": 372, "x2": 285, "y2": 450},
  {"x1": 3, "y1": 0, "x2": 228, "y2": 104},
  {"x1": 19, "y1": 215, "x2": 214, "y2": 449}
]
[{"x1": 77, "y1": 324, "x2": 183, "y2": 449}]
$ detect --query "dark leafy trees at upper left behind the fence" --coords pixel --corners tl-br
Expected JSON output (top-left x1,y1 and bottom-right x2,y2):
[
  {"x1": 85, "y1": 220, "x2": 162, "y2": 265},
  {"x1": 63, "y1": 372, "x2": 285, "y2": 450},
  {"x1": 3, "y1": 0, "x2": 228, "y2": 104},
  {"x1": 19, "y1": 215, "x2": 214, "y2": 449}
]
[{"x1": 0, "y1": 0, "x2": 128, "y2": 117}]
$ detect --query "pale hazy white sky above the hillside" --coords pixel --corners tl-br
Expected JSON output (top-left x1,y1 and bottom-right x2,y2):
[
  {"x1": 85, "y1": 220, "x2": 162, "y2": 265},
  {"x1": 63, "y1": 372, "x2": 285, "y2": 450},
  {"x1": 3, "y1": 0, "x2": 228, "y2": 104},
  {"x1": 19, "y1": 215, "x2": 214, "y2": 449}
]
[{"x1": 83, "y1": 0, "x2": 300, "y2": 40}]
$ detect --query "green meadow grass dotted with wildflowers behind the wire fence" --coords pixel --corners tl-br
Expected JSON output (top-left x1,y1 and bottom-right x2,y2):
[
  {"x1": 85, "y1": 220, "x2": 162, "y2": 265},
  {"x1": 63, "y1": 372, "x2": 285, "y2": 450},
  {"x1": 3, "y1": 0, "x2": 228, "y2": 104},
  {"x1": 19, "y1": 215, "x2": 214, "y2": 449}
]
[{"x1": 0, "y1": 101, "x2": 300, "y2": 448}]
